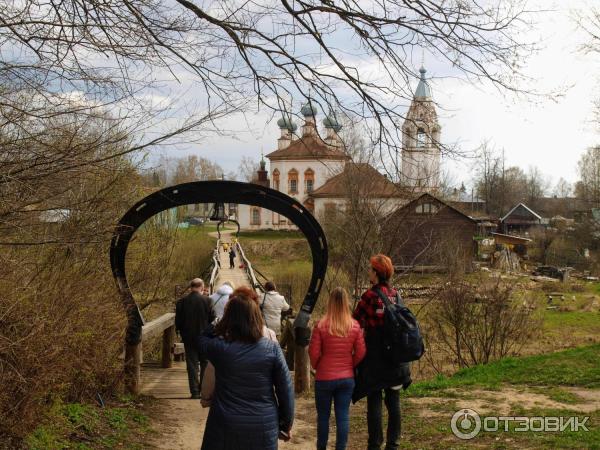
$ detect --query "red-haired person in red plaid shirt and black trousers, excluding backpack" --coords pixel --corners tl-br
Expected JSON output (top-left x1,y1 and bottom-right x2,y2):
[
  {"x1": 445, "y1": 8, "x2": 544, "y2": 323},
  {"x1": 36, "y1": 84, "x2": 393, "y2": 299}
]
[{"x1": 352, "y1": 254, "x2": 411, "y2": 450}]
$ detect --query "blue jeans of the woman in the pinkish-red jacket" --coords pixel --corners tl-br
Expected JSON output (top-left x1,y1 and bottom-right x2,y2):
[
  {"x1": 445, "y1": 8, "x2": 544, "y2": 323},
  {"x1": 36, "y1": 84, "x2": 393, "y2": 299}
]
[{"x1": 315, "y1": 378, "x2": 354, "y2": 450}]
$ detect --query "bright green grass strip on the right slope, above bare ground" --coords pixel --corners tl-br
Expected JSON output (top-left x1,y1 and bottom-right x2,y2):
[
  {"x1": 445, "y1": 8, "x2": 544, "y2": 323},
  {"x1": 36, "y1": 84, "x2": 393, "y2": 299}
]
[{"x1": 408, "y1": 344, "x2": 600, "y2": 396}]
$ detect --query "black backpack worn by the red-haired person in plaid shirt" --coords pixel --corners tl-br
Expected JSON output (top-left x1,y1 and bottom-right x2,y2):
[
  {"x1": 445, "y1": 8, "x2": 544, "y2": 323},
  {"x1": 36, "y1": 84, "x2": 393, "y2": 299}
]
[{"x1": 375, "y1": 288, "x2": 425, "y2": 364}]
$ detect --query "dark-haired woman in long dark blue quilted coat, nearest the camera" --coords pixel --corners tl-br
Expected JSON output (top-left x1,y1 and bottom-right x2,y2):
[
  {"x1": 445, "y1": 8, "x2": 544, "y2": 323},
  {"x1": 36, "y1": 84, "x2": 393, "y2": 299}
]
[{"x1": 199, "y1": 290, "x2": 294, "y2": 450}]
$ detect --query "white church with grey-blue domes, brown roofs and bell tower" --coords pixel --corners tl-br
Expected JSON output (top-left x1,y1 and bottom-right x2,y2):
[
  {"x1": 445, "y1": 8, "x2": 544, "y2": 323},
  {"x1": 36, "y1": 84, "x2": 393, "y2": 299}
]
[{"x1": 237, "y1": 68, "x2": 441, "y2": 230}]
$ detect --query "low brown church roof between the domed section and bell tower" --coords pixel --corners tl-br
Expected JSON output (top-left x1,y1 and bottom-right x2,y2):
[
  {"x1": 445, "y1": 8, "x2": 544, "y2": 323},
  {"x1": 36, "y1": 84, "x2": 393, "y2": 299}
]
[{"x1": 310, "y1": 162, "x2": 407, "y2": 198}]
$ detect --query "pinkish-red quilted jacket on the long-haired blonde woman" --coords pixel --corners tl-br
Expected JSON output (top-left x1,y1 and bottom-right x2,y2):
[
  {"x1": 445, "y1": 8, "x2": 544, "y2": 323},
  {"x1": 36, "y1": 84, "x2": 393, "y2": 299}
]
[{"x1": 308, "y1": 319, "x2": 366, "y2": 381}]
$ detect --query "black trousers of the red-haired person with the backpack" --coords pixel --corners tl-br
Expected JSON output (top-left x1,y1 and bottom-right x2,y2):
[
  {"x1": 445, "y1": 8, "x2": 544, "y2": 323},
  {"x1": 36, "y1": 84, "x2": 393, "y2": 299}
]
[{"x1": 367, "y1": 389, "x2": 401, "y2": 450}]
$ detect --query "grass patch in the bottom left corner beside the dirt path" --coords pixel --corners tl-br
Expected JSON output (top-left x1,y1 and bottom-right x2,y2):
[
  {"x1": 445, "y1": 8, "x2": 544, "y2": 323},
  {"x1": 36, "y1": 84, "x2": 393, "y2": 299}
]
[{"x1": 25, "y1": 399, "x2": 152, "y2": 450}]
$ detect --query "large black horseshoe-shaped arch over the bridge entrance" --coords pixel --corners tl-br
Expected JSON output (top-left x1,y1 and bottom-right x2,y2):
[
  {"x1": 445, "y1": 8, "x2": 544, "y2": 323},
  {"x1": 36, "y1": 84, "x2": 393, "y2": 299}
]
[{"x1": 110, "y1": 181, "x2": 327, "y2": 345}]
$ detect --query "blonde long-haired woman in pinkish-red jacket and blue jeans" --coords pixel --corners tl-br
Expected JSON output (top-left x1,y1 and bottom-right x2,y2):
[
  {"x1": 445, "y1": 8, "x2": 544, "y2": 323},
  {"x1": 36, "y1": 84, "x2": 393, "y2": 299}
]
[{"x1": 308, "y1": 287, "x2": 366, "y2": 450}]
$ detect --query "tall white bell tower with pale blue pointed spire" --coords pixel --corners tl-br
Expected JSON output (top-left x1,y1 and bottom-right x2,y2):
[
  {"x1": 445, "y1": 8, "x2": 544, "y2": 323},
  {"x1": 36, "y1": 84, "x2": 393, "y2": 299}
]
[{"x1": 402, "y1": 67, "x2": 441, "y2": 192}]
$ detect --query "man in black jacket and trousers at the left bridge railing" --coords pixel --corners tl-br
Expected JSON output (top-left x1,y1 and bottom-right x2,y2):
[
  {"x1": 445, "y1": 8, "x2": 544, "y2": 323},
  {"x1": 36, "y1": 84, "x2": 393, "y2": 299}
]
[{"x1": 175, "y1": 278, "x2": 215, "y2": 399}]
